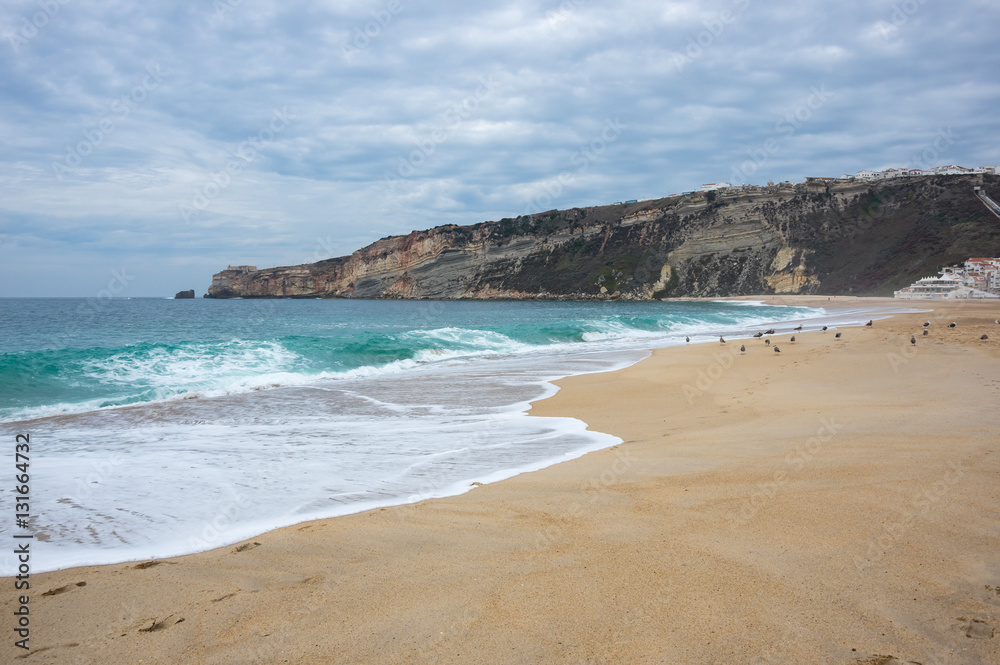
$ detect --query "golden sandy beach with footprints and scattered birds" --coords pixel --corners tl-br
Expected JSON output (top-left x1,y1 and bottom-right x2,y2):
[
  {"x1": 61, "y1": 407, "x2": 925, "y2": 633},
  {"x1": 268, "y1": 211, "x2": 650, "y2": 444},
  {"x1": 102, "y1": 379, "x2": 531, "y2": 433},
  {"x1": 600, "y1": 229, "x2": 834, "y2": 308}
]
[{"x1": 0, "y1": 296, "x2": 1000, "y2": 665}]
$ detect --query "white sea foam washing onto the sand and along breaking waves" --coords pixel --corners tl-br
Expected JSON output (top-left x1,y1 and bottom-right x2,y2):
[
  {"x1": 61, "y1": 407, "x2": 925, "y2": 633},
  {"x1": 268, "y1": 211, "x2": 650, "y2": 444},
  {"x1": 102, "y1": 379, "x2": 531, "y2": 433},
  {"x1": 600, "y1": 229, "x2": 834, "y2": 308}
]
[{"x1": 0, "y1": 300, "x2": 916, "y2": 574}]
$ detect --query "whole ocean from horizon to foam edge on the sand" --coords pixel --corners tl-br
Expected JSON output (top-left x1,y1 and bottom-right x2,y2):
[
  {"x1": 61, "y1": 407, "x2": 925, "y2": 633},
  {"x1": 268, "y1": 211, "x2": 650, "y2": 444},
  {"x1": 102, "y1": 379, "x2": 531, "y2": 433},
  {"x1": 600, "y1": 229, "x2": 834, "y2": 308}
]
[{"x1": 0, "y1": 298, "x2": 868, "y2": 575}]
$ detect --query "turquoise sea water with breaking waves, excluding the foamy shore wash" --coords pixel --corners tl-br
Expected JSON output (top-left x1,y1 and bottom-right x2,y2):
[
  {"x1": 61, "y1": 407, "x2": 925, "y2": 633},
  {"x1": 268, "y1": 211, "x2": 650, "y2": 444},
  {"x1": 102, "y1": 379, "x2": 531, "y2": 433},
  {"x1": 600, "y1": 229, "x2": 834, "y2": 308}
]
[{"x1": 0, "y1": 299, "x2": 820, "y2": 421}]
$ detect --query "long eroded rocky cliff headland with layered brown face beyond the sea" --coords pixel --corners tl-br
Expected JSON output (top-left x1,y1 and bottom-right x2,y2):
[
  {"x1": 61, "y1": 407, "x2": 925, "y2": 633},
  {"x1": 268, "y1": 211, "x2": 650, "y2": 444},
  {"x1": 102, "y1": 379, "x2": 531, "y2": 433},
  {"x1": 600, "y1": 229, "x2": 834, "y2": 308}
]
[{"x1": 209, "y1": 176, "x2": 1000, "y2": 299}]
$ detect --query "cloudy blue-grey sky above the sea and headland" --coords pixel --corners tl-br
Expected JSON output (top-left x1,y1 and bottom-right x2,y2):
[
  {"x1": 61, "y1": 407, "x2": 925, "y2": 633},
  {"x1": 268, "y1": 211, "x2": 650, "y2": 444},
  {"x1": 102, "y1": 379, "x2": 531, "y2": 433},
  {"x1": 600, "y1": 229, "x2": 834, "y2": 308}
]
[{"x1": 0, "y1": 0, "x2": 1000, "y2": 296}]
